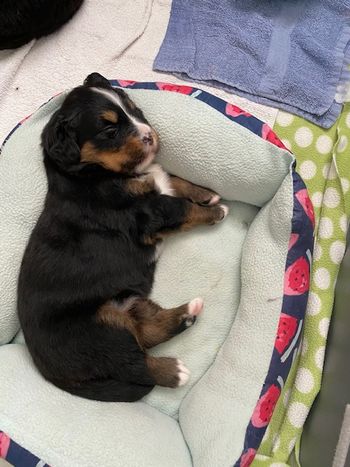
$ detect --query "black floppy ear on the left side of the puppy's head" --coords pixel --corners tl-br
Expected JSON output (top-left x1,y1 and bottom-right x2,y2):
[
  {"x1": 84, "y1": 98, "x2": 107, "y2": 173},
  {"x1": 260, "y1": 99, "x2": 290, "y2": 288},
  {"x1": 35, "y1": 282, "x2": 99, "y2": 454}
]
[{"x1": 41, "y1": 110, "x2": 80, "y2": 172}]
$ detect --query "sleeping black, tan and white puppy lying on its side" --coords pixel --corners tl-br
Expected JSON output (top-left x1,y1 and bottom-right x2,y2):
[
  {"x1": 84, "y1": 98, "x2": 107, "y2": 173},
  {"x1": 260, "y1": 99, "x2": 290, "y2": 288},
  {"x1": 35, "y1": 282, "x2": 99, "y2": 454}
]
[{"x1": 18, "y1": 73, "x2": 227, "y2": 401}]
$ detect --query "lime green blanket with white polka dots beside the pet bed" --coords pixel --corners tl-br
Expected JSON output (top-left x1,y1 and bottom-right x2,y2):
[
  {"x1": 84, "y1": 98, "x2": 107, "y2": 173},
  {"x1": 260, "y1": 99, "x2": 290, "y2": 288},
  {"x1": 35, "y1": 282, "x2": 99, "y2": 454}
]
[{"x1": 252, "y1": 104, "x2": 350, "y2": 467}]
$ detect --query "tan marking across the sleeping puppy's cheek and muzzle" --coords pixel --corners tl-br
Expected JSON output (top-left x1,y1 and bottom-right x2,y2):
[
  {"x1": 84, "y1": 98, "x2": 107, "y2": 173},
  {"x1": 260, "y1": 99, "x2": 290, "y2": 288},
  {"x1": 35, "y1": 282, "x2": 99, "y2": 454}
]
[{"x1": 81, "y1": 136, "x2": 146, "y2": 173}]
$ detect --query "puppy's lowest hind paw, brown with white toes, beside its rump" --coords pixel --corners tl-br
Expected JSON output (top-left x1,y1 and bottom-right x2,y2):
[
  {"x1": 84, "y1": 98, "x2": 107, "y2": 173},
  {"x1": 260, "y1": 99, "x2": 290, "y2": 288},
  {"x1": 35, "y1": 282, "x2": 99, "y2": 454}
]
[{"x1": 146, "y1": 355, "x2": 190, "y2": 388}]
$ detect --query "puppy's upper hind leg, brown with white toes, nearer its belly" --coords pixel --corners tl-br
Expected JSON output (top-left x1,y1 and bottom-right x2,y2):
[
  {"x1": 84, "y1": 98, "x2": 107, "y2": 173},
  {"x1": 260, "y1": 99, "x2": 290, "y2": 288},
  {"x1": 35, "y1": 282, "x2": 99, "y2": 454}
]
[{"x1": 126, "y1": 298, "x2": 203, "y2": 349}]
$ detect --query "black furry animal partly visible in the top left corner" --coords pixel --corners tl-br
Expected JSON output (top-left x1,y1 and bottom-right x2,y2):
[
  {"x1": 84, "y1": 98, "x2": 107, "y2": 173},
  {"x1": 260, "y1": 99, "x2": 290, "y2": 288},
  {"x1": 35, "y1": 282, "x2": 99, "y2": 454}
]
[{"x1": 0, "y1": 0, "x2": 83, "y2": 49}]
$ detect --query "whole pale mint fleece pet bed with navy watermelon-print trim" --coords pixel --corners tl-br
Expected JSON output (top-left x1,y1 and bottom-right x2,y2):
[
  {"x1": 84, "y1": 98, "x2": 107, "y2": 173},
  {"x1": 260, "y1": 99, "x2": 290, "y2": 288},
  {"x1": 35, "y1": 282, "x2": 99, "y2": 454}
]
[{"x1": 0, "y1": 81, "x2": 314, "y2": 467}]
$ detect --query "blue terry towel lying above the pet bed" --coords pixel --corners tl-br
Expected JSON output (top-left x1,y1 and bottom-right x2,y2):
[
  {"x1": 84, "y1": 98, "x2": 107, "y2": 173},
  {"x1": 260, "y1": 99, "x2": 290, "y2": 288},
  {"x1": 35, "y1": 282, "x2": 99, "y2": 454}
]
[{"x1": 154, "y1": 0, "x2": 350, "y2": 128}]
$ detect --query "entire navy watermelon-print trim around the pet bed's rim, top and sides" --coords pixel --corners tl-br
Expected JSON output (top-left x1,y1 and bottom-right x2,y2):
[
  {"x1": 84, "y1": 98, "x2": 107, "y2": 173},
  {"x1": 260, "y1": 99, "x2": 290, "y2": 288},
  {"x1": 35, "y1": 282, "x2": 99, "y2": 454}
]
[{"x1": 0, "y1": 80, "x2": 315, "y2": 467}]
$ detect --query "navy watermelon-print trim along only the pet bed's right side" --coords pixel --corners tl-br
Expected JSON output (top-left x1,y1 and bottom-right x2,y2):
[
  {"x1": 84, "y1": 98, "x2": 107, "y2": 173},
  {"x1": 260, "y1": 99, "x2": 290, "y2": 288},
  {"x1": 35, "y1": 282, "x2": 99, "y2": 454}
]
[{"x1": 235, "y1": 172, "x2": 313, "y2": 467}]
